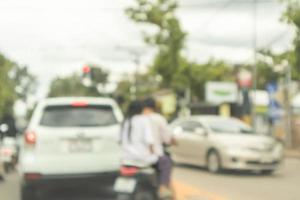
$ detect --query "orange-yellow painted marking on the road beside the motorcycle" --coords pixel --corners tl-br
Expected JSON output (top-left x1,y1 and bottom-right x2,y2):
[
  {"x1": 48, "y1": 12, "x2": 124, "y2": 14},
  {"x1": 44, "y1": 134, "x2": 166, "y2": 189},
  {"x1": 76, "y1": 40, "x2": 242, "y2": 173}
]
[{"x1": 173, "y1": 181, "x2": 227, "y2": 200}]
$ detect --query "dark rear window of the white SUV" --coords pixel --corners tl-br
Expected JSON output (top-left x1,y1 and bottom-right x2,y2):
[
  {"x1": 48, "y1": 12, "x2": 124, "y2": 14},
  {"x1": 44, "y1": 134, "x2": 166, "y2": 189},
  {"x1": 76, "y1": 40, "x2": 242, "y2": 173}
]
[{"x1": 40, "y1": 105, "x2": 118, "y2": 127}]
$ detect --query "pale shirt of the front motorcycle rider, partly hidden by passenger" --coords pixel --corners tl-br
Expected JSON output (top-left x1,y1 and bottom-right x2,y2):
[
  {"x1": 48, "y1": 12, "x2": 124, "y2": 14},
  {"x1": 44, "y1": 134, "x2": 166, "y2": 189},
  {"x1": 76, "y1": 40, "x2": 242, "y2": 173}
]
[{"x1": 147, "y1": 113, "x2": 172, "y2": 157}]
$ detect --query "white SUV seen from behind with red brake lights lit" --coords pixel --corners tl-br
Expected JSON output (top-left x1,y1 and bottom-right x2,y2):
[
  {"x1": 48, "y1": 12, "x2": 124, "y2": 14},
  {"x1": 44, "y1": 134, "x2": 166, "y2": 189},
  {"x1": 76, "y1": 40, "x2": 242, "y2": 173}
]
[{"x1": 19, "y1": 97, "x2": 123, "y2": 200}]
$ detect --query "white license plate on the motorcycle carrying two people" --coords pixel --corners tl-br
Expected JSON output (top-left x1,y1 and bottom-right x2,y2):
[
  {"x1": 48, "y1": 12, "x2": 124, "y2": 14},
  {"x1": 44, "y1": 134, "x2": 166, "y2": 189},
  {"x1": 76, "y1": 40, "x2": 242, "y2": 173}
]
[{"x1": 114, "y1": 177, "x2": 137, "y2": 194}]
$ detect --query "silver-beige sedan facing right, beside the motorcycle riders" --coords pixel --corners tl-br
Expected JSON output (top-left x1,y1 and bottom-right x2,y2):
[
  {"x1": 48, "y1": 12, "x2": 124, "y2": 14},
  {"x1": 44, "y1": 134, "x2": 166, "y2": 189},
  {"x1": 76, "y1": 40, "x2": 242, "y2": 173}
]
[{"x1": 171, "y1": 116, "x2": 283, "y2": 174}]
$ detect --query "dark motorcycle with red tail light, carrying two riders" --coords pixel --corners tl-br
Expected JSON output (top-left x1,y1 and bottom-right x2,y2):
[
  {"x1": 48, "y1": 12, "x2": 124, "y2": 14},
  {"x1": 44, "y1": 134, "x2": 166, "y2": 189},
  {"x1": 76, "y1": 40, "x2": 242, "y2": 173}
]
[{"x1": 114, "y1": 166, "x2": 169, "y2": 200}]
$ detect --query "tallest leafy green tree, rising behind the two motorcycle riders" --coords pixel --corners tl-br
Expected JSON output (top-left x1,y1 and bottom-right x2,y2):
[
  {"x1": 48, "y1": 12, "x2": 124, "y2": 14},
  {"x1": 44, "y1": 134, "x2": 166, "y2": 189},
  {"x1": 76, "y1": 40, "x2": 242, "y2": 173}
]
[{"x1": 126, "y1": 0, "x2": 186, "y2": 87}]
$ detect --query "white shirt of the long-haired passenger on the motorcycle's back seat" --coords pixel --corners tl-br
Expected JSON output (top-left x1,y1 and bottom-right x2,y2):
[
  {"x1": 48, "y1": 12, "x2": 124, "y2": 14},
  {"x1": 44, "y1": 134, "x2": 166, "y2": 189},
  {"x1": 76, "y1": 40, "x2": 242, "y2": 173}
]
[{"x1": 121, "y1": 115, "x2": 158, "y2": 167}]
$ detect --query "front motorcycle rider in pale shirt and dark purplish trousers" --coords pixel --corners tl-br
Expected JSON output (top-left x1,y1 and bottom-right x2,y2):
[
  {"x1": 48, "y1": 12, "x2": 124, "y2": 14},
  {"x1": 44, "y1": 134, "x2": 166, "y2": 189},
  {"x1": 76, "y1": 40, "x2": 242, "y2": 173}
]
[{"x1": 143, "y1": 98, "x2": 176, "y2": 198}]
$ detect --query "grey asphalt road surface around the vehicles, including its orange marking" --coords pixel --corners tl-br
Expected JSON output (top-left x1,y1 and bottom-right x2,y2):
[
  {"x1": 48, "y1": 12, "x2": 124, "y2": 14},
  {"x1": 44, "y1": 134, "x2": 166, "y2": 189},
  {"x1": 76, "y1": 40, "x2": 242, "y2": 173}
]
[{"x1": 0, "y1": 159, "x2": 300, "y2": 200}]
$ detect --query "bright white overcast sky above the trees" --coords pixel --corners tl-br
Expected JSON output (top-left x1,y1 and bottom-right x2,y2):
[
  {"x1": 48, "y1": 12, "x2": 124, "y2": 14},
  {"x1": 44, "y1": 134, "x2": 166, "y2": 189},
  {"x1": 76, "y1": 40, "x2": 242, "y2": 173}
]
[{"x1": 0, "y1": 0, "x2": 293, "y2": 97}]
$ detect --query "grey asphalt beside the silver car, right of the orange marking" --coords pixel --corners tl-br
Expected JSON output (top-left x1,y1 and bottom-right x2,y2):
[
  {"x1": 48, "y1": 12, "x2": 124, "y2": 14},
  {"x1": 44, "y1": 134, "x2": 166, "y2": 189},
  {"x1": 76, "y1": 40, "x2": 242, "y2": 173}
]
[{"x1": 175, "y1": 159, "x2": 300, "y2": 200}]
